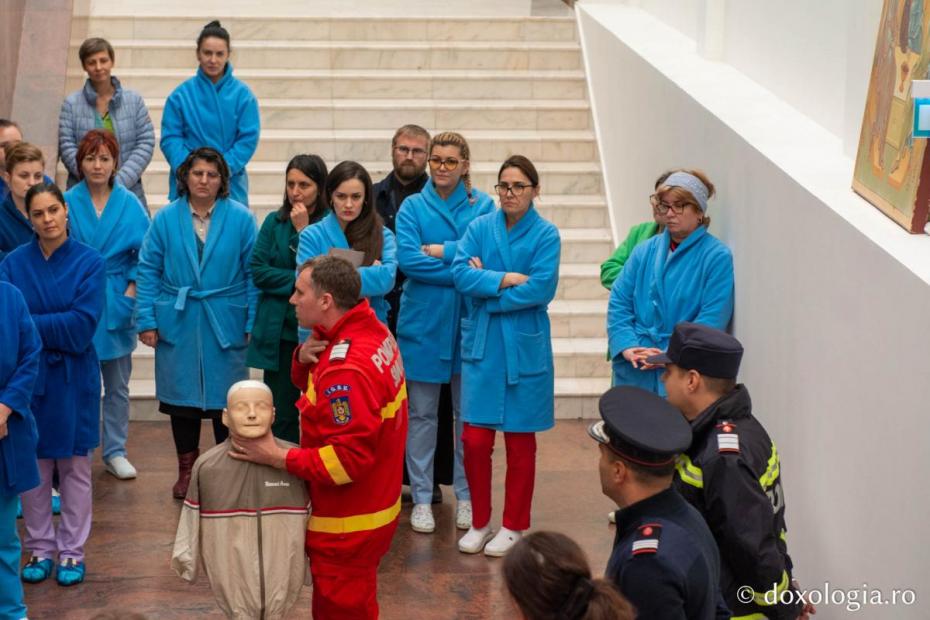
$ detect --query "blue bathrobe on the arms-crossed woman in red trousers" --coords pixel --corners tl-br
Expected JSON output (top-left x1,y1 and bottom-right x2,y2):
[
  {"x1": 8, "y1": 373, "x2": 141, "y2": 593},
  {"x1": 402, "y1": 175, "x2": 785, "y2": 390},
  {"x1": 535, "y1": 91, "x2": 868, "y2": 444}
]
[{"x1": 452, "y1": 205, "x2": 562, "y2": 433}]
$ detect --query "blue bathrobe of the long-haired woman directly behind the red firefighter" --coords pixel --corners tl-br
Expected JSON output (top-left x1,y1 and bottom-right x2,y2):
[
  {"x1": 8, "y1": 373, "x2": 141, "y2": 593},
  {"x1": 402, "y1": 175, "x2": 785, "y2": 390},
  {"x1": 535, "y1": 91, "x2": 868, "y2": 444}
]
[{"x1": 297, "y1": 212, "x2": 397, "y2": 342}]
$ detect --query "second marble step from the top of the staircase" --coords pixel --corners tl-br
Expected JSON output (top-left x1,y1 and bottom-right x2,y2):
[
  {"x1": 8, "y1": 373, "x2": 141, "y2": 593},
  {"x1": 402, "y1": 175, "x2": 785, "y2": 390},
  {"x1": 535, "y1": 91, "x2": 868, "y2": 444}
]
[{"x1": 68, "y1": 39, "x2": 581, "y2": 73}]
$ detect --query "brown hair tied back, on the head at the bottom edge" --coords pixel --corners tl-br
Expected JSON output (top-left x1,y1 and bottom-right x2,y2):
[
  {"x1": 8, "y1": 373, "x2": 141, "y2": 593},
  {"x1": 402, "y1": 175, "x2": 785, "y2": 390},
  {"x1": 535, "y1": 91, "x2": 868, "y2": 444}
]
[{"x1": 502, "y1": 532, "x2": 634, "y2": 620}]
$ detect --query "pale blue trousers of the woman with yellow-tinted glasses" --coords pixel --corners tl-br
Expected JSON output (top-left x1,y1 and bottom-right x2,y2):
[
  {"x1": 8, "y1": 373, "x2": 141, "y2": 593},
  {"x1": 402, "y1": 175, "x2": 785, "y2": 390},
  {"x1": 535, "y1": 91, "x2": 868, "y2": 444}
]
[{"x1": 406, "y1": 375, "x2": 471, "y2": 504}]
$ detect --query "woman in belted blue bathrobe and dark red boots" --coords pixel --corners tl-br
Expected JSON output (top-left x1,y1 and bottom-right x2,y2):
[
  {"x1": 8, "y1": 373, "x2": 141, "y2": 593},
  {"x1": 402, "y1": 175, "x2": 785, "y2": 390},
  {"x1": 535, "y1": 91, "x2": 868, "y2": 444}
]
[{"x1": 136, "y1": 147, "x2": 258, "y2": 499}]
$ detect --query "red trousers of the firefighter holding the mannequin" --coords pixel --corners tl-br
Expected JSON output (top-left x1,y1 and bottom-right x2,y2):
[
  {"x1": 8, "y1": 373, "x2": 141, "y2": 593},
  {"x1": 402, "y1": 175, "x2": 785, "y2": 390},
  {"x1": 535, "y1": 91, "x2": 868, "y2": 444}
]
[{"x1": 310, "y1": 557, "x2": 378, "y2": 620}]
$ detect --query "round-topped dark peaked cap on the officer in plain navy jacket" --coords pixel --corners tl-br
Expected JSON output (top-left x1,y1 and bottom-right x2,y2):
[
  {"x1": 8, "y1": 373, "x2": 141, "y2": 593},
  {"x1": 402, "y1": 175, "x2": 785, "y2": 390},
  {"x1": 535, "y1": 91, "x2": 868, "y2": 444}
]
[{"x1": 588, "y1": 386, "x2": 691, "y2": 467}]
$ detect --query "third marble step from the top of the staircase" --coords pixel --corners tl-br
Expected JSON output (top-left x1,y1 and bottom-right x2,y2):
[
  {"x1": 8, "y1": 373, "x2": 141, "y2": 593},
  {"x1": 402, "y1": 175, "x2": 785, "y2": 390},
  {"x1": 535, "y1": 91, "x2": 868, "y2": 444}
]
[{"x1": 65, "y1": 68, "x2": 586, "y2": 99}]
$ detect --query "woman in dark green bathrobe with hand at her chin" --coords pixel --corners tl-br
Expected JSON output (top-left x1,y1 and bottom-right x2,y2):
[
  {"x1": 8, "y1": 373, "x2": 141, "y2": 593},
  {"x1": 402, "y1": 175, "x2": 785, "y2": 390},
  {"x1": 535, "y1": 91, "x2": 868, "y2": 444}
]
[{"x1": 246, "y1": 155, "x2": 328, "y2": 443}]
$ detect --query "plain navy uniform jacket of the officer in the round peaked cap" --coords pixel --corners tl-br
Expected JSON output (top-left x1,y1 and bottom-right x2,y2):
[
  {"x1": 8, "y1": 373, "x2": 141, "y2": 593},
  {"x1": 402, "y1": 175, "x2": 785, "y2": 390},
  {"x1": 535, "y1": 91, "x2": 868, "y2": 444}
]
[{"x1": 607, "y1": 488, "x2": 730, "y2": 620}]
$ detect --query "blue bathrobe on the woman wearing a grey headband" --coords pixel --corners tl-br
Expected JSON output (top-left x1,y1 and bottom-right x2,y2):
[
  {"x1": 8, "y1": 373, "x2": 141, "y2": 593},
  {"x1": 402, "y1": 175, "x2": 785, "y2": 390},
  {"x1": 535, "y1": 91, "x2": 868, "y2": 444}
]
[{"x1": 607, "y1": 226, "x2": 733, "y2": 396}]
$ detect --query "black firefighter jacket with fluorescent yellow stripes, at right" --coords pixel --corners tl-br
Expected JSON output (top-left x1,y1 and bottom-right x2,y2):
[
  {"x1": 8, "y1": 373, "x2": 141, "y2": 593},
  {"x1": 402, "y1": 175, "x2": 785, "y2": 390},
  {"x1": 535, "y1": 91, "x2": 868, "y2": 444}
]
[{"x1": 675, "y1": 385, "x2": 801, "y2": 619}]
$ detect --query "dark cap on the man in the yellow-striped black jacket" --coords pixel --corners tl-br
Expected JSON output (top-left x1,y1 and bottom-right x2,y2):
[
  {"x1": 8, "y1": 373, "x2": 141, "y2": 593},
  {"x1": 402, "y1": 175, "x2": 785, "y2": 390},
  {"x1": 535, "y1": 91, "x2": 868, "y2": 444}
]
[{"x1": 646, "y1": 323, "x2": 743, "y2": 379}]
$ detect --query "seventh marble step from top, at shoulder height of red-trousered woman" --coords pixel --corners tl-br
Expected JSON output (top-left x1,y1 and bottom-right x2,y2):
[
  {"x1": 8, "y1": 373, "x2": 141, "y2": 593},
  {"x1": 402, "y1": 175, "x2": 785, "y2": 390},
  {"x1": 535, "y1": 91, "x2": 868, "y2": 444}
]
[{"x1": 146, "y1": 193, "x2": 610, "y2": 229}]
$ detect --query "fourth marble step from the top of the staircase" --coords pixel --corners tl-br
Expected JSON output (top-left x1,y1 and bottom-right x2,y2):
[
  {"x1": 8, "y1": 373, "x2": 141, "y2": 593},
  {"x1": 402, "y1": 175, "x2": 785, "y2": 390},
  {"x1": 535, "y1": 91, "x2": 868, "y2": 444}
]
[{"x1": 147, "y1": 98, "x2": 597, "y2": 133}]
